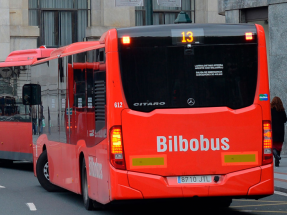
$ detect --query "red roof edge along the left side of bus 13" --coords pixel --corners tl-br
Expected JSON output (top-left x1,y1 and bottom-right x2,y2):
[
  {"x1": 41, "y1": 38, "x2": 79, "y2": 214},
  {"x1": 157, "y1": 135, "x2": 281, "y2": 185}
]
[{"x1": 33, "y1": 41, "x2": 105, "y2": 64}]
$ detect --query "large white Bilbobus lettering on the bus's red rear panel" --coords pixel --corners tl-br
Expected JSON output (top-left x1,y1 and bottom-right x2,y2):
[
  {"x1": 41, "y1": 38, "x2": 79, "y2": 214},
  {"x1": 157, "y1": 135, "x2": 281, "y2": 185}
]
[{"x1": 157, "y1": 135, "x2": 230, "y2": 152}]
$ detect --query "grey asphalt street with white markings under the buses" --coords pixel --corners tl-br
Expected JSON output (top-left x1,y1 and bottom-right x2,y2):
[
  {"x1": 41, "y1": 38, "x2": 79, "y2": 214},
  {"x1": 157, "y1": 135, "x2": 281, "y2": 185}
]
[{"x1": 0, "y1": 163, "x2": 287, "y2": 215}]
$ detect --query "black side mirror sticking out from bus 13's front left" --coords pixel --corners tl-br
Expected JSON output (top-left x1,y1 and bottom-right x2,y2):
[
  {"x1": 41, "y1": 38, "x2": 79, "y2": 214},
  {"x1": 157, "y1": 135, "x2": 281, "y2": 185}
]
[{"x1": 22, "y1": 84, "x2": 41, "y2": 105}]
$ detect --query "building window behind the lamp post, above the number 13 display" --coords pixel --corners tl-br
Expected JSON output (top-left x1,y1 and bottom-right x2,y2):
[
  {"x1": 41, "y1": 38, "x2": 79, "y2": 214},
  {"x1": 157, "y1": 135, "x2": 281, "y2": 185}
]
[{"x1": 136, "y1": 0, "x2": 195, "y2": 26}]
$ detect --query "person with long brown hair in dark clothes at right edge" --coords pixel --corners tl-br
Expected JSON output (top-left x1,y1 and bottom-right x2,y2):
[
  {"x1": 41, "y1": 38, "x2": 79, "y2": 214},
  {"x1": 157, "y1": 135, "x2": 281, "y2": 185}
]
[{"x1": 271, "y1": 96, "x2": 287, "y2": 167}]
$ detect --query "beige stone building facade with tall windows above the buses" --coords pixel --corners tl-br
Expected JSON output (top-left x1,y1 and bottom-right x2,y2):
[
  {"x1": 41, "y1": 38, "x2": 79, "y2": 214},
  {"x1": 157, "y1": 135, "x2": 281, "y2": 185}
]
[{"x1": 0, "y1": 0, "x2": 225, "y2": 62}]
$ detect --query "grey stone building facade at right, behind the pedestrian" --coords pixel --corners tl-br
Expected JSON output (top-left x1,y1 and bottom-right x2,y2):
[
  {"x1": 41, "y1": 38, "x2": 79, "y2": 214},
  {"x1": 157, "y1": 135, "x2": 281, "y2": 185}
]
[{"x1": 218, "y1": 0, "x2": 287, "y2": 154}]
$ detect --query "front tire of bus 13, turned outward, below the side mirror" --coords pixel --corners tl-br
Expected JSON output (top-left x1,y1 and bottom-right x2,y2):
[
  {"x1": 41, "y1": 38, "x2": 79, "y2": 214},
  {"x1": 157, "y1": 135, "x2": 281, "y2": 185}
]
[{"x1": 36, "y1": 150, "x2": 60, "y2": 192}]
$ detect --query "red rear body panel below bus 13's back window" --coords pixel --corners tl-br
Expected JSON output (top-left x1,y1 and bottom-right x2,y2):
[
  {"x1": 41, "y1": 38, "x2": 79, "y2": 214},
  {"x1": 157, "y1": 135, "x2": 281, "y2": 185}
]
[{"x1": 122, "y1": 105, "x2": 262, "y2": 176}]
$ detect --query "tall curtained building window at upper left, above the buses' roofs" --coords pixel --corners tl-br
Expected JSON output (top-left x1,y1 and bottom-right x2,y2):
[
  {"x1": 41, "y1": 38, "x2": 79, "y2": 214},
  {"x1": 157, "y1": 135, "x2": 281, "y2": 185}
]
[{"x1": 29, "y1": 0, "x2": 91, "y2": 47}]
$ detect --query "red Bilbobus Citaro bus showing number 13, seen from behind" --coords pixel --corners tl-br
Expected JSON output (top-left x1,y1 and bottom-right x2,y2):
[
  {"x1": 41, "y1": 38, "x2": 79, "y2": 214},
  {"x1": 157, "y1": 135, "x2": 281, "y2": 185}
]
[{"x1": 31, "y1": 24, "x2": 274, "y2": 209}]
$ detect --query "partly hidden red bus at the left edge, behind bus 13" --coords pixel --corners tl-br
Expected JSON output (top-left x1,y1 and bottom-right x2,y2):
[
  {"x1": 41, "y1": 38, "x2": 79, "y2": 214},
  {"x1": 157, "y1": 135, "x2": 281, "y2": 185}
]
[{"x1": 0, "y1": 48, "x2": 54, "y2": 163}]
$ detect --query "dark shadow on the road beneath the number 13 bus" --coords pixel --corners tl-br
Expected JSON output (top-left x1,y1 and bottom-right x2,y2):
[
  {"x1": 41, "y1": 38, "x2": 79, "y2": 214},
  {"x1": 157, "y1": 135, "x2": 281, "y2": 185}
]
[{"x1": 49, "y1": 191, "x2": 254, "y2": 215}]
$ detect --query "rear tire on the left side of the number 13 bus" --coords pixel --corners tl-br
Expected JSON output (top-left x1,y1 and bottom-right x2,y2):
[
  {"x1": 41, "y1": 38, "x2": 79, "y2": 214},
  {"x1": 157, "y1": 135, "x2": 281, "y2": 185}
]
[{"x1": 81, "y1": 158, "x2": 93, "y2": 211}]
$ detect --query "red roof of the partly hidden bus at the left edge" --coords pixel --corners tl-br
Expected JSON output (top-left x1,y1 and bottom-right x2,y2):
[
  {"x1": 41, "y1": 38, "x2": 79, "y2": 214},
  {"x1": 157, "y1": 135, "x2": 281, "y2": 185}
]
[{"x1": 0, "y1": 48, "x2": 55, "y2": 67}]
